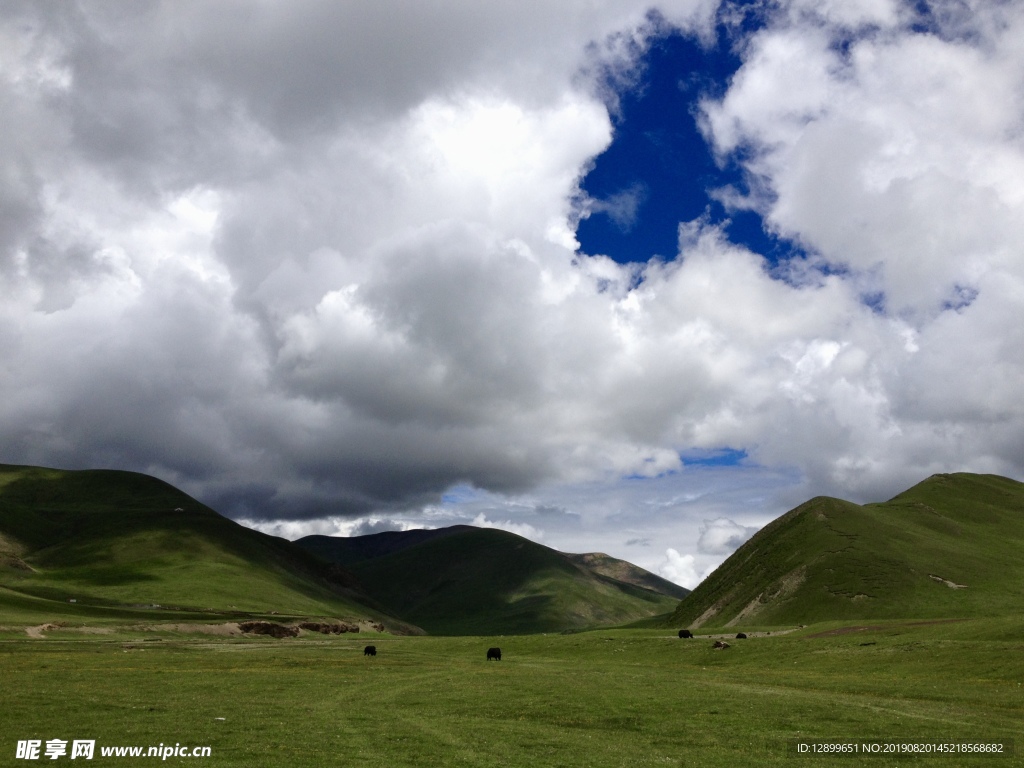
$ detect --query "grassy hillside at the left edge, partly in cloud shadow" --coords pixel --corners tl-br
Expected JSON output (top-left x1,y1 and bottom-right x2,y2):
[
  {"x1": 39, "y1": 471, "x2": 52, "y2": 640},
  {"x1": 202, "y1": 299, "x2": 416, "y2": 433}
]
[{"x1": 0, "y1": 465, "x2": 395, "y2": 621}]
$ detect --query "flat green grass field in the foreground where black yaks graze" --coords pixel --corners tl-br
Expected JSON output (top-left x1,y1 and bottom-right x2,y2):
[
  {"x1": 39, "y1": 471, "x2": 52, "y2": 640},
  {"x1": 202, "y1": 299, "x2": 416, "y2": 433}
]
[{"x1": 0, "y1": 616, "x2": 1024, "y2": 768}]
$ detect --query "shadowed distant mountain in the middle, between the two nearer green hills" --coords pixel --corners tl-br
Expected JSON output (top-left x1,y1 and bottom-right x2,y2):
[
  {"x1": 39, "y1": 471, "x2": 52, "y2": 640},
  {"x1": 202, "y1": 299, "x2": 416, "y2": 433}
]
[{"x1": 296, "y1": 525, "x2": 686, "y2": 635}]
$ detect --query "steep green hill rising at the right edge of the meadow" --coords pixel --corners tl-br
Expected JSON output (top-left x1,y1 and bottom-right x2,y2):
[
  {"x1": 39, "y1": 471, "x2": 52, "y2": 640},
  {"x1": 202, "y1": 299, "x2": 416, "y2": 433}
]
[{"x1": 669, "y1": 473, "x2": 1024, "y2": 628}]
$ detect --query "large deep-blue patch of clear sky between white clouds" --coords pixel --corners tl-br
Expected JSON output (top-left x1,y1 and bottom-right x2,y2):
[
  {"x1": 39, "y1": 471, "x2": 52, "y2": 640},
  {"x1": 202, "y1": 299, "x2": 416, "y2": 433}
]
[{"x1": 577, "y1": 12, "x2": 801, "y2": 264}]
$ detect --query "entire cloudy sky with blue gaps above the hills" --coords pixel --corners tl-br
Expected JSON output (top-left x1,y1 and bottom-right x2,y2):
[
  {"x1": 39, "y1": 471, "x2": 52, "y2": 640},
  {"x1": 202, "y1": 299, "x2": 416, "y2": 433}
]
[{"x1": 0, "y1": 0, "x2": 1024, "y2": 587}]
